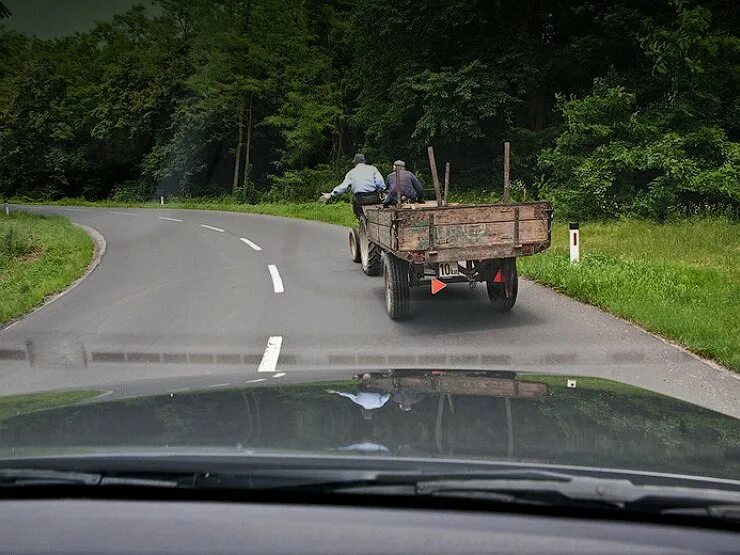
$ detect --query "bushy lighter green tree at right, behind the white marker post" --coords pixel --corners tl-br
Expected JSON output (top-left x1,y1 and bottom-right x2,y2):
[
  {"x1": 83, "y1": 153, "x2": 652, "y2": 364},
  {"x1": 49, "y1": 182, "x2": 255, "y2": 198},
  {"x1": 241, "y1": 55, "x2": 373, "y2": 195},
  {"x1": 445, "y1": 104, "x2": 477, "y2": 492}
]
[{"x1": 540, "y1": 4, "x2": 740, "y2": 219}]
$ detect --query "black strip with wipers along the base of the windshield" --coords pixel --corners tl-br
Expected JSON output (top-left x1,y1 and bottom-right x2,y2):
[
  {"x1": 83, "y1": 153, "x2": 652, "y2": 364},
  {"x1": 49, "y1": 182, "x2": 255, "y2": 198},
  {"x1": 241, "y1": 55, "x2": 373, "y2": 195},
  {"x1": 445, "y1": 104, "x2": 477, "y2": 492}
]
[{"x1": 5, "y1": 468, "x2": 740, "y2": 522}]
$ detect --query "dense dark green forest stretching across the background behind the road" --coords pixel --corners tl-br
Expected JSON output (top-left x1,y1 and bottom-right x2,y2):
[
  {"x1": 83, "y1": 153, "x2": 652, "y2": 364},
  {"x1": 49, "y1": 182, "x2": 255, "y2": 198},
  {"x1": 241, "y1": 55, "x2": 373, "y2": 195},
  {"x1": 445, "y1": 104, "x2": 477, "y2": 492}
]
[{"x1": 0, "y1": 0, "x2": 740, "y2": 220}]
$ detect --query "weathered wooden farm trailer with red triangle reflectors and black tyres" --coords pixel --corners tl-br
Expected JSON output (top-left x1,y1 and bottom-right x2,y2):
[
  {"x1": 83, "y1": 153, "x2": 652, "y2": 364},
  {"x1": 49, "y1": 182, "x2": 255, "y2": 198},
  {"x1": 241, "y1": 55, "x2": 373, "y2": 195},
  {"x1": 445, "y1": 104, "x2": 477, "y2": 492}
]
[{"x1": 349, "y1": 201, "x2": 552, "y2": 320}]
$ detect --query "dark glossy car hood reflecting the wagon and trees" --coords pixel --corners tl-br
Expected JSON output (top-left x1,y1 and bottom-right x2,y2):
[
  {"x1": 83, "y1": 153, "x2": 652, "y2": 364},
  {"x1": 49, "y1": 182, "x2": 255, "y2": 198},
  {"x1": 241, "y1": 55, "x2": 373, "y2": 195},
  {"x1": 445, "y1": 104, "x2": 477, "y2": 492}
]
[{"x1": 0, "y1": 371, "x2": 740, "y2": 479}]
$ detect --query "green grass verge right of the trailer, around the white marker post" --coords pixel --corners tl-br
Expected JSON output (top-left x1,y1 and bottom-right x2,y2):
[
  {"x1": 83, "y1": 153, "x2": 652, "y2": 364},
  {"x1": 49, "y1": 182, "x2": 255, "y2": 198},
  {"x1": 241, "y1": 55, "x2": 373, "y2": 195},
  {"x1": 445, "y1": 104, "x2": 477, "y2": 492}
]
[{"x1": 520, "y1": 219, "x2": 740, "y2": 371}]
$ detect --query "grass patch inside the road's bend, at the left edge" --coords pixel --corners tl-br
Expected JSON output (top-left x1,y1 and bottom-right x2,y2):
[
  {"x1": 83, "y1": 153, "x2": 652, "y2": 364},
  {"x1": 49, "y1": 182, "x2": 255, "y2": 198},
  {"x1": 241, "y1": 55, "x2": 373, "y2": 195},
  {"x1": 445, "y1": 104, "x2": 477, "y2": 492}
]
[{"x1": 0, "y1": 212, "x2": 93, "y2": 324}]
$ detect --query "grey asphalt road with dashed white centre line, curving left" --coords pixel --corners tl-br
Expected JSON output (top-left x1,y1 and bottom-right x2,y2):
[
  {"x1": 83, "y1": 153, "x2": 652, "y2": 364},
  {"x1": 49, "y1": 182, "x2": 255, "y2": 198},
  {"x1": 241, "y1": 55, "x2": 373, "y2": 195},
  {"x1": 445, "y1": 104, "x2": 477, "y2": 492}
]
[{"x1": 0, "y1": 207, "x2": 740, "y2": 416}]
